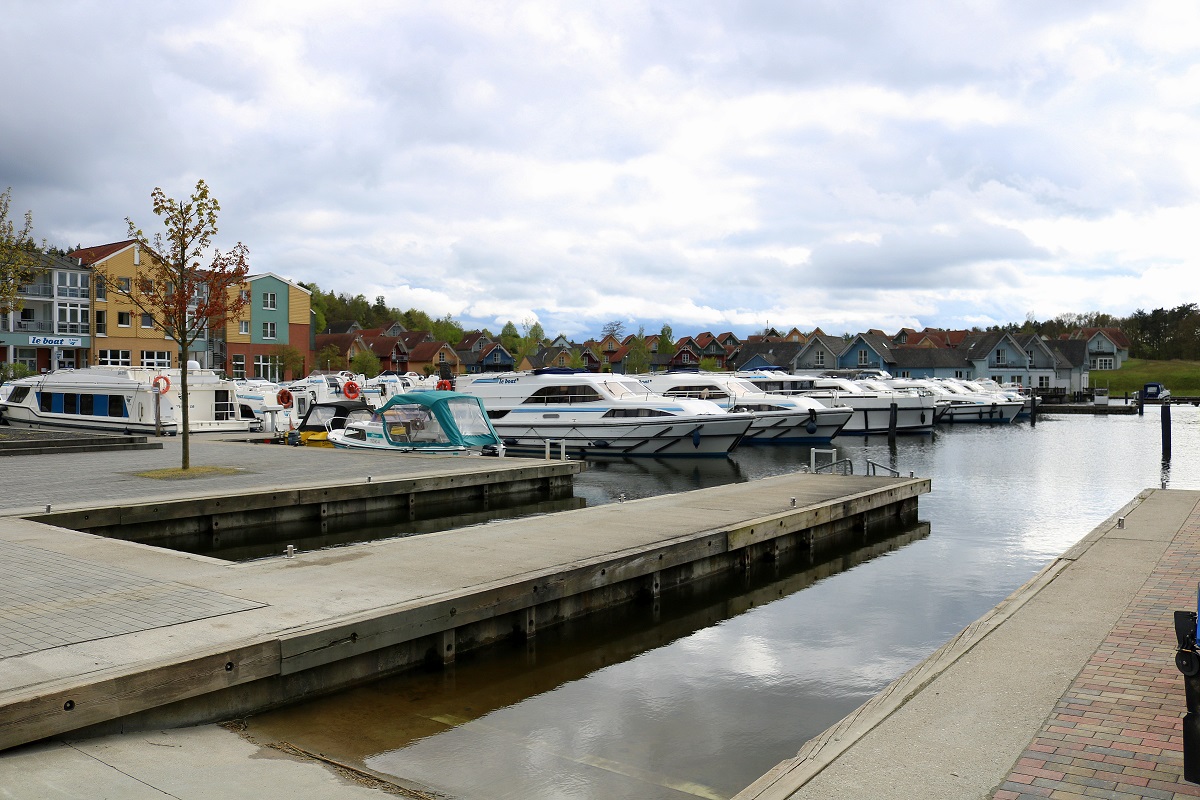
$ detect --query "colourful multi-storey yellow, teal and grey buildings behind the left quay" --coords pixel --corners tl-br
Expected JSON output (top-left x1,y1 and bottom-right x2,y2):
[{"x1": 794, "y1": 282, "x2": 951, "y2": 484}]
[{"x1": 0, "y1": 240, "x2": 313, "y2": 380}]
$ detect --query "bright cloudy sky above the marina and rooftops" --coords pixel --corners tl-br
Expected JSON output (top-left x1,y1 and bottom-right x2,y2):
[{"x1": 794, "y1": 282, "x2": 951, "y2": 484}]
[{"x1": 0, "y1": 0, "x2": 1200, "y2": 338}]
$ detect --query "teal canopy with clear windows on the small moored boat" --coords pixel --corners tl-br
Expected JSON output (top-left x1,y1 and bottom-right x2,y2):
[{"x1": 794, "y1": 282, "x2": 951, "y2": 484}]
[{"x1": 374, "y1": 391, "x2": 500, "y2": 450}]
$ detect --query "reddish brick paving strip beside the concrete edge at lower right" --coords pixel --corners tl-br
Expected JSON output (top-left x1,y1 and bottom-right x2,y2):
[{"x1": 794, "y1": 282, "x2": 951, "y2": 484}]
[{"x1": 992, "y1": 503, "x2": 1200, "y2": 800}]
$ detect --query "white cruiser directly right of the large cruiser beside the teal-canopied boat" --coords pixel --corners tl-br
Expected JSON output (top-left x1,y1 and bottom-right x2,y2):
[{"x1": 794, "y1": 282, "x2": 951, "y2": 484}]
[{"x1": 634, "y1": 371, "x2": 853, "y2": 444}]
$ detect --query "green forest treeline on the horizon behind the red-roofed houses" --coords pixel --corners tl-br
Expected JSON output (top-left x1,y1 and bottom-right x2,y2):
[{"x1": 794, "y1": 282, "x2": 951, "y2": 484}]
[{"x1": 302, "y1": 283, "x2": 1200, "y2": 361}]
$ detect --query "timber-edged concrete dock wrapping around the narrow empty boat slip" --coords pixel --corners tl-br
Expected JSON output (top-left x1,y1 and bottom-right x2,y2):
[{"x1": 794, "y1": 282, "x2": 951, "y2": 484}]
[{"x1": 0, "y1": 443, "x2": 929, "y2": 748}]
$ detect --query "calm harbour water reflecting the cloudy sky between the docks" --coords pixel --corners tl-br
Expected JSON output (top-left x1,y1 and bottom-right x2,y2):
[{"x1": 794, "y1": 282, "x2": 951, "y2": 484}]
[{"x1": 250, "y1": 407, "x2": 1200, "y2": 800}]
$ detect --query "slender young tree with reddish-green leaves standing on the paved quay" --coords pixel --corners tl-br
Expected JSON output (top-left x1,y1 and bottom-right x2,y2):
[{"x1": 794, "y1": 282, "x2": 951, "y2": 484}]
[{"x1": 105, "y1": 179, "x2": 250, "y2": 470}]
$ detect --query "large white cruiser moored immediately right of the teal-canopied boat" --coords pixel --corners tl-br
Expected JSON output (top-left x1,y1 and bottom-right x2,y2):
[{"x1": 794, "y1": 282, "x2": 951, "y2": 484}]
[{"x1": 457, "y1": 368, "x2": 754, "y2": 458}]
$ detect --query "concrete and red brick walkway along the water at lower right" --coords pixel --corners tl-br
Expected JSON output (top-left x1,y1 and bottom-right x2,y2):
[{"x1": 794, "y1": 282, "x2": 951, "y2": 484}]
[{"x1": 737, "y1": 489, "x2": 1200, "y2": 800}]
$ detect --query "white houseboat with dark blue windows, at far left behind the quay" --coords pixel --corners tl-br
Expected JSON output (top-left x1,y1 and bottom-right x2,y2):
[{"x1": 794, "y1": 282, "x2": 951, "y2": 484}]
[{"x1": 0, "y1": 361, "x2": 258, "y2": 435}]
